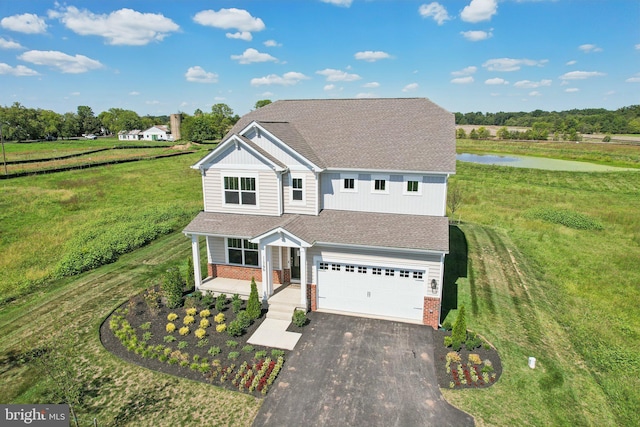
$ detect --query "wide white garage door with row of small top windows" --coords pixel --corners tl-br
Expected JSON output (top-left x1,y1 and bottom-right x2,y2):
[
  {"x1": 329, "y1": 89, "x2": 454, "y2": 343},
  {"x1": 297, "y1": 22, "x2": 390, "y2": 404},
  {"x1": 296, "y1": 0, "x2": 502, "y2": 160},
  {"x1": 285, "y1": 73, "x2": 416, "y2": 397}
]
[{"x1": 316, "y1": 261, "x2": 427, "y2": 321}]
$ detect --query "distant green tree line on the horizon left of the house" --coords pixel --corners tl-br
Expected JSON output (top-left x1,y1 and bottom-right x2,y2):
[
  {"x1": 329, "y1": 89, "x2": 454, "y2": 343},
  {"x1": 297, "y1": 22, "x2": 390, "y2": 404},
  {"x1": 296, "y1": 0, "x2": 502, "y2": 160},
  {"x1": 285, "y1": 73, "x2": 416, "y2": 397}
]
[{"x1": 0, "y1": 102, "x2": 169, "y2": 142}]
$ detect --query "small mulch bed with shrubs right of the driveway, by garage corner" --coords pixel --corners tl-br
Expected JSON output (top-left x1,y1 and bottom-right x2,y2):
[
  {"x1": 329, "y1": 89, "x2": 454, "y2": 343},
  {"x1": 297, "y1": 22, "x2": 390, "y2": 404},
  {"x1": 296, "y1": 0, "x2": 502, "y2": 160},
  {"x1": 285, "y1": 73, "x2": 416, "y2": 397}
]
[{"x1": 433, "y1": 330, "x2": 502, "y2": 389}]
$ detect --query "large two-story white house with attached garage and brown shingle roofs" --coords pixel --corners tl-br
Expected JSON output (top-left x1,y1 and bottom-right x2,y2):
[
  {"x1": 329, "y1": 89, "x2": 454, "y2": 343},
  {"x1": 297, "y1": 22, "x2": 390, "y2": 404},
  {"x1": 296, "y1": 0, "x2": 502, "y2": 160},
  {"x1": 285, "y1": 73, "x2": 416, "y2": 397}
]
[{"x1": 184, "y1": 98, "x2": 455, "y2": 328}]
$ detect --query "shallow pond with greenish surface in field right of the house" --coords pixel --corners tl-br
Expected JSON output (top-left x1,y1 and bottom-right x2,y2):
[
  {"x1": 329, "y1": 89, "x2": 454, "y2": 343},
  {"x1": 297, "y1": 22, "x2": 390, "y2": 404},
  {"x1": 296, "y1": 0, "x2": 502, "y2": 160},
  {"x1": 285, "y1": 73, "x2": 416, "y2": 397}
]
[{"x1": 456, "y1": 153, "x2": 638, "y2": 172}]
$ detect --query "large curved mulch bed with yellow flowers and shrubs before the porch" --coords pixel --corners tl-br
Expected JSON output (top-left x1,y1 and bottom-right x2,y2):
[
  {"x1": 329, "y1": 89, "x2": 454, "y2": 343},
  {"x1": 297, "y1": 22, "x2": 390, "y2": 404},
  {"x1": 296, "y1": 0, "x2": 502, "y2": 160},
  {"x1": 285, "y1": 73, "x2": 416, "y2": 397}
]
[{"x1": 100, "y1": 294, "x2": 289, "y2": 397}]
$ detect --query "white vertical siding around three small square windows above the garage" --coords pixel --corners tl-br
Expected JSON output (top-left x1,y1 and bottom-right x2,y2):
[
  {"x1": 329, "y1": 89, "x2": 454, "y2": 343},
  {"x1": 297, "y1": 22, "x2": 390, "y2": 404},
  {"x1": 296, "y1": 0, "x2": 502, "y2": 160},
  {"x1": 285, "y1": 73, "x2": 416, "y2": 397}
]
[{"x1": 320, "y1": 173, "x2": 447, "y2": 216}]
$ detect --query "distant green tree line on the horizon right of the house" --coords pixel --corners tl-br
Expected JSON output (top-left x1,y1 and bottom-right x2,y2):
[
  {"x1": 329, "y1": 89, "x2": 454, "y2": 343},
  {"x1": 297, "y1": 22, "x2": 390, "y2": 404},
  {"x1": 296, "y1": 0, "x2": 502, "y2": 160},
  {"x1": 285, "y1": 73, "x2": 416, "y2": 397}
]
[{"x1": 455, "y1": 105, "x2": 640, "y2": 135}]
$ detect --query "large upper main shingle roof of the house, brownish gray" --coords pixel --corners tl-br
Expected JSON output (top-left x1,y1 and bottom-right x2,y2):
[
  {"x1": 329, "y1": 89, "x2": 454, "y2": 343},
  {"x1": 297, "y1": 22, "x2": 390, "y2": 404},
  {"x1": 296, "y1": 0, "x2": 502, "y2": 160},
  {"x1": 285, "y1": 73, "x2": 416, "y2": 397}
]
[{"x1": 227, "y1": 98, "x2": 455, "y2": 172}]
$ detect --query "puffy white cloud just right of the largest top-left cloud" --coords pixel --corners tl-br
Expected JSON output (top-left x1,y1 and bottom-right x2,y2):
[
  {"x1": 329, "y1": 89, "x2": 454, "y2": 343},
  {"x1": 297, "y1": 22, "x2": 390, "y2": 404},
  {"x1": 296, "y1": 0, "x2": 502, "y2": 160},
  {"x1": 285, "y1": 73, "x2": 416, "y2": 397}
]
[{"x1": 193, "y1": 8, "x2": 265, "y2": 41}]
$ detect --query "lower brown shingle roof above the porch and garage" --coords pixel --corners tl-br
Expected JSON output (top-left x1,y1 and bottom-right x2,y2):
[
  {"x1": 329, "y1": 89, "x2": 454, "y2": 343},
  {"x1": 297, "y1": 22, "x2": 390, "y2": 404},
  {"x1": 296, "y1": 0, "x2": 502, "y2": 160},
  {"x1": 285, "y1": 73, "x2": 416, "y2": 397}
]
[{"x1": 183, "y1": 209, "x2": 449, "y2": 253}]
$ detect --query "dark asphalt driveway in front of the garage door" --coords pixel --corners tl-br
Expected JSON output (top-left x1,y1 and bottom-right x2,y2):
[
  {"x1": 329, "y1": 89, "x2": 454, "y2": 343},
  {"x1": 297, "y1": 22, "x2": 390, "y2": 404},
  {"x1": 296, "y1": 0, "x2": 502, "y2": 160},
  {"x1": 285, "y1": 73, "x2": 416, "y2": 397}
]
[{"x1": 253, "y1": 312, "x2": 474, "y2": 427}]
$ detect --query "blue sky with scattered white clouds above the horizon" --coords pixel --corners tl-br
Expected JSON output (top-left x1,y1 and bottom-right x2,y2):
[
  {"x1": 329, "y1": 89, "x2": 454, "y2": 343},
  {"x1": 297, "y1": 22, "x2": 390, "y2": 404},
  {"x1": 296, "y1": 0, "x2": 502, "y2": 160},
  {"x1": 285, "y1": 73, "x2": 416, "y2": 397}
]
[{"x1": 0, "y1": 0, "x2": 640, "y2": 115}]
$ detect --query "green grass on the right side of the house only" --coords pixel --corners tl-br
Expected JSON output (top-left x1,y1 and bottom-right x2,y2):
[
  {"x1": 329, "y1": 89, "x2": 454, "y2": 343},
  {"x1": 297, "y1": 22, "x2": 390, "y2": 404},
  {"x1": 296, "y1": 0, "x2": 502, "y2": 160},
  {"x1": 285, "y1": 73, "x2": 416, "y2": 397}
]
[{"x1": 443, "y1": 155, "x2": 640, "y2": 426}]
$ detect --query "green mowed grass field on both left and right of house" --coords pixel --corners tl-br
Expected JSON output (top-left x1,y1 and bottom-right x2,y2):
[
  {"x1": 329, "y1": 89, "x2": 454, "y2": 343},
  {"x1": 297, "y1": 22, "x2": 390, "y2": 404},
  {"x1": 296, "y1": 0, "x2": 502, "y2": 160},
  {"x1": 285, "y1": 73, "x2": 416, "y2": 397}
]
[{"x1": 0, "y1": 141, "x2": 640, "y2": 426}]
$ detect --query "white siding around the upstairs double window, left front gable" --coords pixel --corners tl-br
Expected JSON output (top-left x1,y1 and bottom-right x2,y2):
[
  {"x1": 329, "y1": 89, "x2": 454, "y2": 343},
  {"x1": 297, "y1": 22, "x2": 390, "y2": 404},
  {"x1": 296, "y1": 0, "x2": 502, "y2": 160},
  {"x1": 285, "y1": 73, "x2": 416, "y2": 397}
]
[{"x1": 202, "y1": 169, "x2": 279, "y2": 215}]
